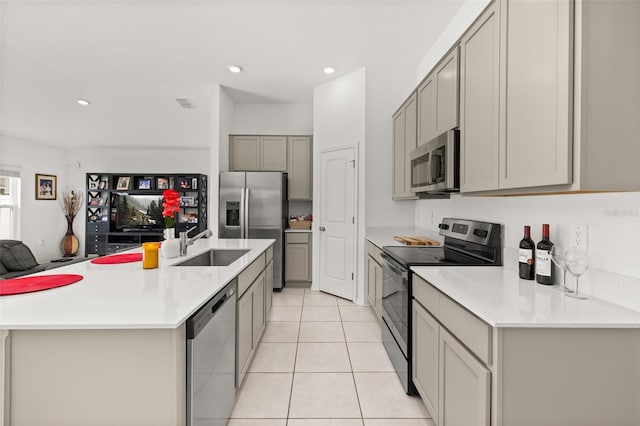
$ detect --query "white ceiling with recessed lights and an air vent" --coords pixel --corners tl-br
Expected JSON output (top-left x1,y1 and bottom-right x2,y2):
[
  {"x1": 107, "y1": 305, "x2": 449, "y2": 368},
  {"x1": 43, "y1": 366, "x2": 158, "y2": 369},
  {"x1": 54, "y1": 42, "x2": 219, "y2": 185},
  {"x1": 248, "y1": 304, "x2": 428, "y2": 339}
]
[{"x1": 0, "y1": 0, "x2": 463, "y2": 147}]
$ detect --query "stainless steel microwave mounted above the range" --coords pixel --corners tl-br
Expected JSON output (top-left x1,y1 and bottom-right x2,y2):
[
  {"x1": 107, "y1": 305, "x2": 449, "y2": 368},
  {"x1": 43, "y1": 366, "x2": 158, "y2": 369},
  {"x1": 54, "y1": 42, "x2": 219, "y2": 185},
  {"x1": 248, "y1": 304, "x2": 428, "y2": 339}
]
[{"x1": 410, "y1": 129, "x2": 460, "y2": 196}]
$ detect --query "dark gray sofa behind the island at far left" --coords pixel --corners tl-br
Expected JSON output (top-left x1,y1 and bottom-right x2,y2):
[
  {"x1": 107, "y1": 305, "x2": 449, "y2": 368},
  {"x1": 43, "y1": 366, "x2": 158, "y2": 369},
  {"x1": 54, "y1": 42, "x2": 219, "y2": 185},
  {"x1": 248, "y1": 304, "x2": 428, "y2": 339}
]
[{"x1": 0, "y1": 240, "x2": 87, "y2": 280}]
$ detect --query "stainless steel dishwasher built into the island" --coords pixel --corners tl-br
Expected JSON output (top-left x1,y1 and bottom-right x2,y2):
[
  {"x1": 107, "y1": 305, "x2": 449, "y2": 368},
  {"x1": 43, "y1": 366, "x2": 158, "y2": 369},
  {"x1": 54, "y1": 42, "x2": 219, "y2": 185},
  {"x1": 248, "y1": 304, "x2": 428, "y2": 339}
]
[{"x1": 187, "y1": 280, "x2": 237, "y2": 426}]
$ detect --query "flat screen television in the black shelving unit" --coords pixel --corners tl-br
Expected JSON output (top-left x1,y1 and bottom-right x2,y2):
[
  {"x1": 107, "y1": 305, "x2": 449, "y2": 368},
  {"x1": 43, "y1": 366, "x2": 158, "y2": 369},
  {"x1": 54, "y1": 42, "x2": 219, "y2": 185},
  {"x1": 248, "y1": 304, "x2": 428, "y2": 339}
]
[{"x1": 115, "y1": 194, "x2": 164, "y2": 230}]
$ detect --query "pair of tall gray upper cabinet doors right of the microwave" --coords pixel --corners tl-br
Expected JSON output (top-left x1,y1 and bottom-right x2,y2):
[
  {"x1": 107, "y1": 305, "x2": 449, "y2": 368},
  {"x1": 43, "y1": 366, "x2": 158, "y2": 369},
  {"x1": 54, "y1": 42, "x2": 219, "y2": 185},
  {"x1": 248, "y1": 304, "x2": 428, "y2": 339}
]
[{"x1": 460, "y1": 0, "x2": 573, "y2": 192}]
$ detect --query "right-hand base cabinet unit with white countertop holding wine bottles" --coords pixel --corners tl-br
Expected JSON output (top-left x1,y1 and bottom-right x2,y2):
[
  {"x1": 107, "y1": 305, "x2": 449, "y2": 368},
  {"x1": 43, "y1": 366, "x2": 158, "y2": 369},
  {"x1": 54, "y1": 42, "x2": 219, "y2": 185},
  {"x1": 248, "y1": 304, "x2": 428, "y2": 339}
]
[{"x1": 411, "y1": 267, "x2": 640, "y2": 426}]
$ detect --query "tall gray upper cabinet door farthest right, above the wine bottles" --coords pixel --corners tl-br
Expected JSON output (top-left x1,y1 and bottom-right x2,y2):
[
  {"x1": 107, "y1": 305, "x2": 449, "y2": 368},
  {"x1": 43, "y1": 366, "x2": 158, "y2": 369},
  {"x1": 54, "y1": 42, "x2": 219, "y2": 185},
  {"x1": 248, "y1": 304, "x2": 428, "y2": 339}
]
[{"x1": 499, "y1": 0, "x2": 573, "y2": 189}]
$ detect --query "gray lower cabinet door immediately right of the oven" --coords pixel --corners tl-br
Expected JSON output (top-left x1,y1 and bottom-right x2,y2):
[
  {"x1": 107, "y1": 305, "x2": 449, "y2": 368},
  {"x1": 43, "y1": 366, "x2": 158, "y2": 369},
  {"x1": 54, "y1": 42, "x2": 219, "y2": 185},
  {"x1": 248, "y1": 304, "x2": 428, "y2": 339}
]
[{"x1": 412, "y1": 300, "x2": 440, "y2": 419}]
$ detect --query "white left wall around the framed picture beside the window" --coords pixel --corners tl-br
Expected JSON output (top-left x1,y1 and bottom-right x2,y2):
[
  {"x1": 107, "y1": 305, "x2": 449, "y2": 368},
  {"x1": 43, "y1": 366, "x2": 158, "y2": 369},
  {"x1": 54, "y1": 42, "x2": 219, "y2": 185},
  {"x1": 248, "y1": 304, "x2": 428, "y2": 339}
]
[{"x1": 0, "y1": 136, "x2": 70, "y2": 260}]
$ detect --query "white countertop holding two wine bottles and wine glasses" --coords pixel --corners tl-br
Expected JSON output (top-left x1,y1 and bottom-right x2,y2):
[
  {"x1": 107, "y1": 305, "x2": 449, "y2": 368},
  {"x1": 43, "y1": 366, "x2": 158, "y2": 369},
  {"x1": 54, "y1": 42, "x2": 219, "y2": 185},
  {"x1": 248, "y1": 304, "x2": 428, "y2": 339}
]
[{"x1": 411, "y1": 266, "x2": 640, "y2": 328}]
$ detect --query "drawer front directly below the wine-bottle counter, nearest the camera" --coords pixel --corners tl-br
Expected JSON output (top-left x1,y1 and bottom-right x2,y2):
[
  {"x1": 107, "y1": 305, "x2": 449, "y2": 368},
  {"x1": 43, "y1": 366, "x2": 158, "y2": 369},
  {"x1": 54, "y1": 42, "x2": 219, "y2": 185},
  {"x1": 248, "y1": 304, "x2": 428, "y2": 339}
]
[{"x1": 438, "y1": 294, "x2": 491, "y2": 364}]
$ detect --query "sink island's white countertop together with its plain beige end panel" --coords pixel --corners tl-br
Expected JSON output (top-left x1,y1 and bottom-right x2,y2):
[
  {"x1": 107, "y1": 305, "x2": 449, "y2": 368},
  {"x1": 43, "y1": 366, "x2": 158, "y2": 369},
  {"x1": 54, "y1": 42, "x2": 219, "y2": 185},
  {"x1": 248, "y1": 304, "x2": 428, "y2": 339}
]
[{"x1": 0, "y1": 239, "x2": 274, "y2": 426}]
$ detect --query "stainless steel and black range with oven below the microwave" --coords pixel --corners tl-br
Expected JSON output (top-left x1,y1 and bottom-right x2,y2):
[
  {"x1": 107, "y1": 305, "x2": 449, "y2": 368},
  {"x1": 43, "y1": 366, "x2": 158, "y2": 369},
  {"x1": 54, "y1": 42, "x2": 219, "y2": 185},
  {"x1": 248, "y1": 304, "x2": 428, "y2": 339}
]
[{"x1": 382, "y1": 218, "x2": 502, "y2": 395}]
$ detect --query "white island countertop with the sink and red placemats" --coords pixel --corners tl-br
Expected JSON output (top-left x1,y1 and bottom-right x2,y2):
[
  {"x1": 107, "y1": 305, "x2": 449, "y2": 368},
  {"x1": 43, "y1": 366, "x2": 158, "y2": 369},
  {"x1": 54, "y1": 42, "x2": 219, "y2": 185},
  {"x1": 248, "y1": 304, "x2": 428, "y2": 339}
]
[{"x1": 0, "y1": 239, "x2": 274, "y2": 329}]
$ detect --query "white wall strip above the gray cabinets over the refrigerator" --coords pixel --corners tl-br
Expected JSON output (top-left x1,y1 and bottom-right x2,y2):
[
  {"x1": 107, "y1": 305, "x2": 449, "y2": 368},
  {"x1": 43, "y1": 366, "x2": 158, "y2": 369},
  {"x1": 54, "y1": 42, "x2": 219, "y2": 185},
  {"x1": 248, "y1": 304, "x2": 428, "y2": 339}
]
[{"x1": 231, "y1": 104, "x2": 313, "y2": 135}]
